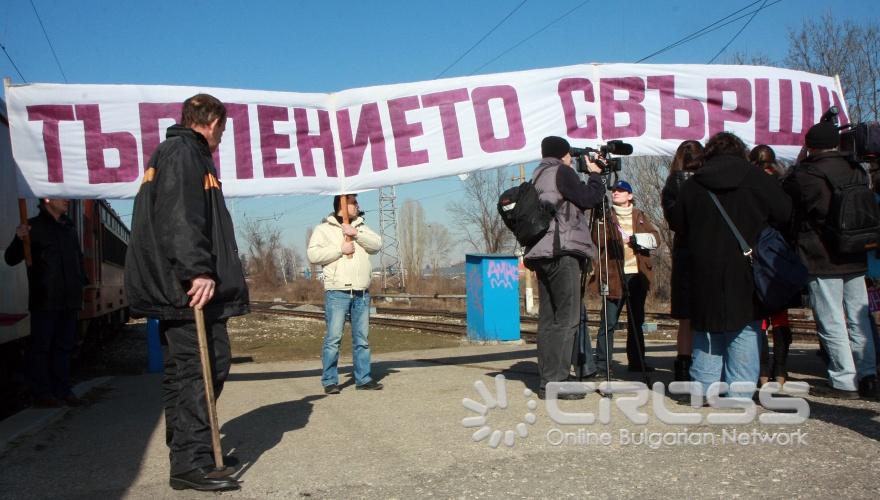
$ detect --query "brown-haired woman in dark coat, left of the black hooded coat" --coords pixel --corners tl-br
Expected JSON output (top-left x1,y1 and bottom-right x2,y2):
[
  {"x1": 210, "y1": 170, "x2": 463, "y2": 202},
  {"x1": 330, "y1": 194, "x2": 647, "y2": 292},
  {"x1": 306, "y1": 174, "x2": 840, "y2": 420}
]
[{"x1": 660, "y1": 141, "x2": 703, "y2": 382}]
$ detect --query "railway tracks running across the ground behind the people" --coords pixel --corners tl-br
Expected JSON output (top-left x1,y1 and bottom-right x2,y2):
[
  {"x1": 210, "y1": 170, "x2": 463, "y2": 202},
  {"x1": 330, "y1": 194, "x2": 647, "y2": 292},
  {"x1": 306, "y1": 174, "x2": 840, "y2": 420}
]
[{"x1": 251, "y1": 301, "x2": 816, "y2": 342}]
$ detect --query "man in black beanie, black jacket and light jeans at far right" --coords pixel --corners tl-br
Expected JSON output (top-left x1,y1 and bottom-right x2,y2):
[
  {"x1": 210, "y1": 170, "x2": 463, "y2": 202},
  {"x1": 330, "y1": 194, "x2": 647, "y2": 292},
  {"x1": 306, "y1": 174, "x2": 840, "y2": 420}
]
[{"x1": 785, "y1": 122, "x2": 878, "y2": 399}]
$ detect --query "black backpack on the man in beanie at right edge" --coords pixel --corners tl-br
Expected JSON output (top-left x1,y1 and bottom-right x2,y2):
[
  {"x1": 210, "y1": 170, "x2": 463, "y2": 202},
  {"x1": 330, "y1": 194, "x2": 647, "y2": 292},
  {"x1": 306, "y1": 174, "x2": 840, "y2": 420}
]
[{"x1": 814, "y1": 165, "x2": 880, "y2": 253}]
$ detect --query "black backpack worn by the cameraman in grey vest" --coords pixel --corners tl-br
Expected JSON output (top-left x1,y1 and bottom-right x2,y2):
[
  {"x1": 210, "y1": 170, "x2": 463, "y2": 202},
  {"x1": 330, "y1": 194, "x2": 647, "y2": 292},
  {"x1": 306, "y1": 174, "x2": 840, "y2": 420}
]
[{"x1": 498, "y1": 169, "x2": 556, "y2": 247}]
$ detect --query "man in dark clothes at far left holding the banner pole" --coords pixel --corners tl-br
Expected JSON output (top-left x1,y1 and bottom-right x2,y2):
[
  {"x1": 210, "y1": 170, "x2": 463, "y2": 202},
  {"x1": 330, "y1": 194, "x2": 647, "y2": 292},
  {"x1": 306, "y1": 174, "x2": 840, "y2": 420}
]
[{"x1": 4, "y1": 198, "x2": 86, "y2": 408}]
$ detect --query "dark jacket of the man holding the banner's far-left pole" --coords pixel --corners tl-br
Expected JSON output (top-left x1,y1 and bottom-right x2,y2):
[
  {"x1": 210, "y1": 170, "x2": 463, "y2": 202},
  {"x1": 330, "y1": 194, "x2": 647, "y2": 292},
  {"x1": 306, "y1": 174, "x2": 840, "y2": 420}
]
[{"x1": 4, "y1": 208, "x2": 86, "y2": 311}]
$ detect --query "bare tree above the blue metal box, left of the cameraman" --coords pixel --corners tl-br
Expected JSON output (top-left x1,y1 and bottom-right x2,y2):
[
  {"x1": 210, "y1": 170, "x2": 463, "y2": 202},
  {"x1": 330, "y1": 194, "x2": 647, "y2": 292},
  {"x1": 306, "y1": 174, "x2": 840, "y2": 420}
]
[{"x1": 447, "y1": 168, "x2": 515, "y2": 253}]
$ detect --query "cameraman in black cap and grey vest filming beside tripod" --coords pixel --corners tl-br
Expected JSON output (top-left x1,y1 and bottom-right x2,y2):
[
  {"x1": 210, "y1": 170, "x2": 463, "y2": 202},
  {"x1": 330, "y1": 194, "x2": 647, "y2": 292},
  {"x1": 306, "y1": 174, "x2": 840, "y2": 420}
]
[{"x1": 524, "y1": 136, "x2": 605, "y2": 399}]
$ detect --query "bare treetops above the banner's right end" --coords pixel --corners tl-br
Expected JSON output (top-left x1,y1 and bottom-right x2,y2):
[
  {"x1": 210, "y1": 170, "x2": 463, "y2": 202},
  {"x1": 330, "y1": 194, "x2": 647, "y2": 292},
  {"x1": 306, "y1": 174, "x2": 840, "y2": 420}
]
[{"x1": 785, "y1": 11, "x2": 880, "y2": 122}]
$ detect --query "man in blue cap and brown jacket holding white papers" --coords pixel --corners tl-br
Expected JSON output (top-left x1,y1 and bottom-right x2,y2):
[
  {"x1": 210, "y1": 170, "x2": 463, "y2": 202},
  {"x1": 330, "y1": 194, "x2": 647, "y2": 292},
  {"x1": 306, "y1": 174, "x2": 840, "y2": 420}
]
[{"x1": 590, "y1": 181, "x2": 660, "y2": 372}]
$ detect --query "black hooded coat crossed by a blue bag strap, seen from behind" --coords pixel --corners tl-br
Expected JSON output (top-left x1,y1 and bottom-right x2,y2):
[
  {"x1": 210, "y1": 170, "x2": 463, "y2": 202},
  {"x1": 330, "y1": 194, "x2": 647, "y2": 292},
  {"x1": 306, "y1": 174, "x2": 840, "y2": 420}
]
[{"x1": 669, "y1": 155, "x2": 791, "y2": 332}]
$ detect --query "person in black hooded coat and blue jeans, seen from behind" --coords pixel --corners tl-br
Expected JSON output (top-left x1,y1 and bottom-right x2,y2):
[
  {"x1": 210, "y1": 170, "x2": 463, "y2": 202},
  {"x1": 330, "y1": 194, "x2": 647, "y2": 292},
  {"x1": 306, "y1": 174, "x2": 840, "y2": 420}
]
[{"x1": 670, "y1": 132, "x2": 791, "y2": 397}]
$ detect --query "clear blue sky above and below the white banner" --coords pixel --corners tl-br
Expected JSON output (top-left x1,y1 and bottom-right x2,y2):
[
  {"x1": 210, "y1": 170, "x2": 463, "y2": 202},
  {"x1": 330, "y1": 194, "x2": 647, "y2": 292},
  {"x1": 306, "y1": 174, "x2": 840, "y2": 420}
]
[{"x1": 0, "y1": 0, "x2": 880, "y2": 262}]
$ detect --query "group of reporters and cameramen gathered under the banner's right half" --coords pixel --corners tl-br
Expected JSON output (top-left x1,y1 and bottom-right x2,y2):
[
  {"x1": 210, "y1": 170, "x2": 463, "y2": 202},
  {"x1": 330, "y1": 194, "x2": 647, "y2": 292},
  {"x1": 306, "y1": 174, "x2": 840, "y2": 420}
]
[{"x1": 525, "y1": 121, "x2": 880, "y2": 406}]
